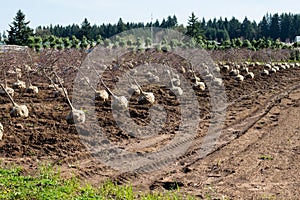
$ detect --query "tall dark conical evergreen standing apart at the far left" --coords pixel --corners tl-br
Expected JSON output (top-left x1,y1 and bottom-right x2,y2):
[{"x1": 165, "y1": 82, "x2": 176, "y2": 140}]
[{"x1": 7, "y1": 10, "x2": 33, "y2": 45}]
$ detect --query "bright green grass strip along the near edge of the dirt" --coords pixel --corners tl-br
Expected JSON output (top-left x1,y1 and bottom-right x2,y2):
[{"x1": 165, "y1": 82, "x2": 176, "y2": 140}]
[{"x1": 0, "y1": 163, "x2": 194, "y2": 200}]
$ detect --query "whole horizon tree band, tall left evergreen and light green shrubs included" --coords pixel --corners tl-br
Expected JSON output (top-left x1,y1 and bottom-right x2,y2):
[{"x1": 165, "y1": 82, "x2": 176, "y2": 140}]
[{"x1": 0, "y1": 10, "x2": 300, "y2": 50}]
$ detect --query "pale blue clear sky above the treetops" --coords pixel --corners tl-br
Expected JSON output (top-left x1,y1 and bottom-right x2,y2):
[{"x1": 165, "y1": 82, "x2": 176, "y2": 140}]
[{"x1": 0, "y1": 0, "x2": 300, "y2": 33}]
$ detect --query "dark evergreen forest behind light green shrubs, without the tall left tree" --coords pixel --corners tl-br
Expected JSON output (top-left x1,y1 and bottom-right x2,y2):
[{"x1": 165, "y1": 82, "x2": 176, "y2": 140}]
[{"x1": 32, "y1": 13, "x2": 300, "y2": 42}]
